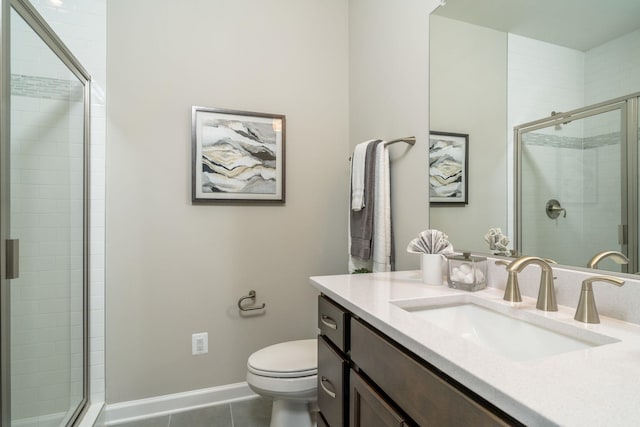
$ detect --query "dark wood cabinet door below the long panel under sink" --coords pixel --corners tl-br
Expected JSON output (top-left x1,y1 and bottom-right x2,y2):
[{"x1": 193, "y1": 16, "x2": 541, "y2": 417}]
[{"x1": 349, "y1": 370, "x2": 412, "y2": 427}]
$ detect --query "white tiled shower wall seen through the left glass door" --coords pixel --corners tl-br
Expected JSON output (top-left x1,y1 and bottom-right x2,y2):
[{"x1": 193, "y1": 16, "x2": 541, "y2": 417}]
[{"x1": 11, "y1": 8, "x2": 83, "y2": 425}]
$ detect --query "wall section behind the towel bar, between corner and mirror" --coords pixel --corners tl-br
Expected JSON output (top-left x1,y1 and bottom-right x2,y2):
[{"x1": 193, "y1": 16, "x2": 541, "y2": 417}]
[{"x1": 350, "y1": 0, "x2": 439, "y2": 270}]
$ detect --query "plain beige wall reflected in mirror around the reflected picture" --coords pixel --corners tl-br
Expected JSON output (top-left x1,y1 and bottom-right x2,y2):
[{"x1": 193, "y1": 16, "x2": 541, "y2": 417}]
[{"x1": 429, "y1": 15, "x2": 507, "y2": 252}]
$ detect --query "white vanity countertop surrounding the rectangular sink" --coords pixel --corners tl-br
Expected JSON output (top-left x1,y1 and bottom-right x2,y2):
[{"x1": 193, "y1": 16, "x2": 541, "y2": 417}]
[{"x1": 311, "y1": 271, "x2": 640, "y2": 427}]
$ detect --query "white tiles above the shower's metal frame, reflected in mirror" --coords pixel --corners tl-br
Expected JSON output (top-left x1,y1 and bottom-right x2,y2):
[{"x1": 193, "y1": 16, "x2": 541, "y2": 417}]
[{"x1": 507, "y1": 30, "x2": 640, "y2": 136}]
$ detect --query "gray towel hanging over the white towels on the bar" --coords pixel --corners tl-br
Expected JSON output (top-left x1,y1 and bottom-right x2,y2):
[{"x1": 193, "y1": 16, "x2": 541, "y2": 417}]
[{"x1": 349, "y1": 139, "x2": 382, "y2": 260}]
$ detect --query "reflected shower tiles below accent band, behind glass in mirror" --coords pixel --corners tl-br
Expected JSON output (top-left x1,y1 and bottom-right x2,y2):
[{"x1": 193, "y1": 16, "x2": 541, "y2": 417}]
[{"x1": 522, "y1": 145, "x2": 620, "y2": 266}]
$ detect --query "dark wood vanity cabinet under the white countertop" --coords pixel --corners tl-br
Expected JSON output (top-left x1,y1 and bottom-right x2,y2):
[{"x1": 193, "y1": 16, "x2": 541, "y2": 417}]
[{"x1": 318, "y1": 296, "x2": 522, "y2": 427}]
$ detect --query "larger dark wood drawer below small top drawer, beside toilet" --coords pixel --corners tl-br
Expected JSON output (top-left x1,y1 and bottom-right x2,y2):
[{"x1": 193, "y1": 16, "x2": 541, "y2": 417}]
[{"x1": 318, "y1": 336, "x2": 348, "y2": 427}]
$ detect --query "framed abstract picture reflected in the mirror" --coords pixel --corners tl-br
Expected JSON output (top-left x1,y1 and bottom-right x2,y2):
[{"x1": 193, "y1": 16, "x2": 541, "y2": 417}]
[{"x1": 429, "y1": 131, "x2": 469, "y2": 206}]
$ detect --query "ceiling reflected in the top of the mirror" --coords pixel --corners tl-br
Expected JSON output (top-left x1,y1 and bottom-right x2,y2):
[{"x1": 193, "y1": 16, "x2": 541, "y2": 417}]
[{"x1": 434, "y1": 0, "x2": 640, "y2": 51}]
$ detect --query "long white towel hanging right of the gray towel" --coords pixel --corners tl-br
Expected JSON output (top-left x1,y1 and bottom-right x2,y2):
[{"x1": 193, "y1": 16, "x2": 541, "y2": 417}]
[{"x1": 373, "y1": 143, "x2": 392, "y2": 273}]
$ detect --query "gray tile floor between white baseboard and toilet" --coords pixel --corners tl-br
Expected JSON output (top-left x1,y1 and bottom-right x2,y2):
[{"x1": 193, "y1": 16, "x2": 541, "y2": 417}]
[{"x1": 110, "y1": 398, "x2": 271, "y2": 427}]
